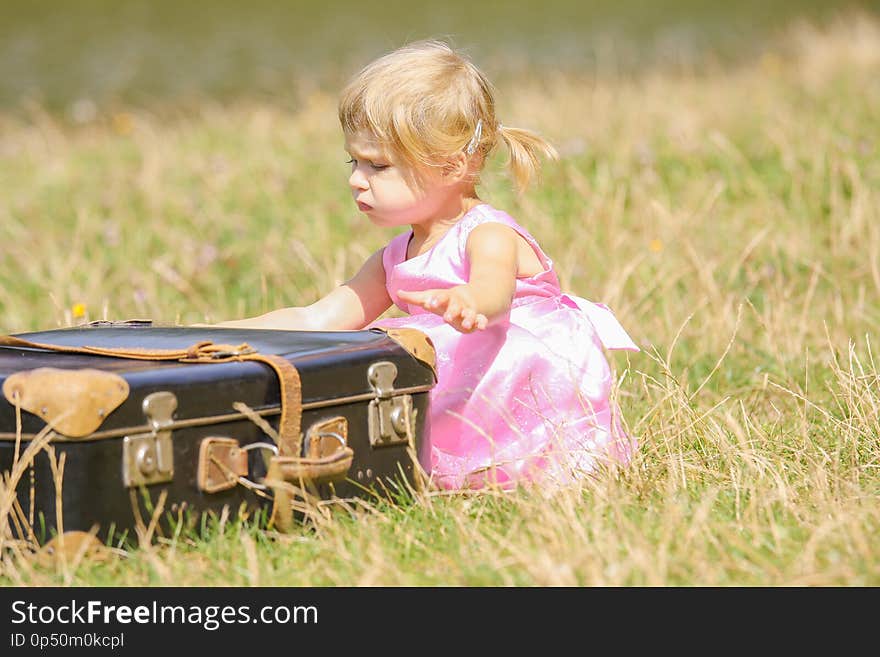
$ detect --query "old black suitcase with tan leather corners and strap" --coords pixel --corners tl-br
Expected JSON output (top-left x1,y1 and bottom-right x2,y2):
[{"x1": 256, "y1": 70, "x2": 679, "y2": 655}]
[{"x1": 0, "y1": 322, "x2": 436, "y2": 543}]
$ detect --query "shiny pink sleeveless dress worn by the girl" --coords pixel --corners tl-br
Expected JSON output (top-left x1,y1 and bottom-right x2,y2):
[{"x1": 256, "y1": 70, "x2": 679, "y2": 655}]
[{"x1": 373, "y1": 204, "x2": 639, "y2": 489}]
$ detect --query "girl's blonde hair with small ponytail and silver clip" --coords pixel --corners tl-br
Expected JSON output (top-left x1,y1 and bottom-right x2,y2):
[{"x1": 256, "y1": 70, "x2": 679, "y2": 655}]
[{"x1": 339, "y1": 41, "x2": 558, "y2": 190}]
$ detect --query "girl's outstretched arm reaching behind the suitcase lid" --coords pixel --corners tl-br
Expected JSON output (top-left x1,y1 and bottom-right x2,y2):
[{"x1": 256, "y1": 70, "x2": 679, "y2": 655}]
[{"x1": 213, "y1": 249, "x2": 391, "y2": 331}]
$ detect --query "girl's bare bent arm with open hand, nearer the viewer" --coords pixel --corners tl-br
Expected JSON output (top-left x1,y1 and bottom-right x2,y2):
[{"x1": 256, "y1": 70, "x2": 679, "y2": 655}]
[{"x1": 398, "y1": 222, "x2": 519, "y2": 333}]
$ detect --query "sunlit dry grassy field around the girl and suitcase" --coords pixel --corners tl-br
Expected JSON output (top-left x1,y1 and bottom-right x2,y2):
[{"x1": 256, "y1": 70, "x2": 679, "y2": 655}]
[{"x1": 0, "y1": 13, "x2": 880, "y2": 586}]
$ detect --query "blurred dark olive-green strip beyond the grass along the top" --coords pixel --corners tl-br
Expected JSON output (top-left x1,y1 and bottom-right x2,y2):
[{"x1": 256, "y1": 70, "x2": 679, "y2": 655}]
[{"x1": 0, "y1": 0, "x2": 880, "y2": 114}]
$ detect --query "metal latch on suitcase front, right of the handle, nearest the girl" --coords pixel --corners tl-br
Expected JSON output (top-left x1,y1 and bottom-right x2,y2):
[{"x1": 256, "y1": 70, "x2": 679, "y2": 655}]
[{"x1": 367, "y1": 361, "x2": 415, "y2": 447}]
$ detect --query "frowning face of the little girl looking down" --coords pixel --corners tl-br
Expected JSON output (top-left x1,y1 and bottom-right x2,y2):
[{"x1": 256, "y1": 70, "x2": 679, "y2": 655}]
[{"x1": 345, "y1": 132, "x2": 455, "y2": 227}]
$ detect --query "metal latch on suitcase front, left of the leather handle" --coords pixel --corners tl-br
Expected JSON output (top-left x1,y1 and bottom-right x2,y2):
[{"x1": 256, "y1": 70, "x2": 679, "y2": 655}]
[{"x1": 122, "y1": 391, "x2": 177, "y2": 488}]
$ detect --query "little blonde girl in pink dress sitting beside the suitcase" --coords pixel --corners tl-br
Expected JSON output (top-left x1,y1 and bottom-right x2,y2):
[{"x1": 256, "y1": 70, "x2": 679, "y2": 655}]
[{"x1": 220, "y1": 42, "x2": 638, "y2": 488}]
